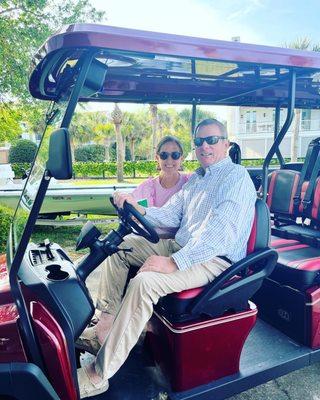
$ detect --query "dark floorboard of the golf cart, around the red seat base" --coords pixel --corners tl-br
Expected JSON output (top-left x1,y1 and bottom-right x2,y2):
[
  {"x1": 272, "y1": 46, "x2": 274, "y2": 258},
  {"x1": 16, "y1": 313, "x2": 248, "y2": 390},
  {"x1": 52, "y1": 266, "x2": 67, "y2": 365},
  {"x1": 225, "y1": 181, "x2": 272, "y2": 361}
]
[{"x1": 92, "y1": 320, "x2": 320, "y2": 400}]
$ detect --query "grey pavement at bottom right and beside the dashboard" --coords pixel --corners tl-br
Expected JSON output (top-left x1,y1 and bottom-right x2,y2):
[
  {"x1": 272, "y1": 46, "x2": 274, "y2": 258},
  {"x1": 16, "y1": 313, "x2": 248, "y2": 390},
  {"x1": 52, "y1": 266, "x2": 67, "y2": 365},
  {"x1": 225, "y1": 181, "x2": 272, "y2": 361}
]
[{"x1": 86, "y1": 262, "x2": 320, "y2": 400}]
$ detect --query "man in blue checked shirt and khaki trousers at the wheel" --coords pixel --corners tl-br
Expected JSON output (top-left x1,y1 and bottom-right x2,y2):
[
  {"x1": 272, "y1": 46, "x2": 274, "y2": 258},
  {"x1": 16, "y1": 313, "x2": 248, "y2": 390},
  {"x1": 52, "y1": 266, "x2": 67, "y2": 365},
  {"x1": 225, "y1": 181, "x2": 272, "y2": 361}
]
[{"x1": 78, "y1": 119, "x2": 256, "y2": 398}]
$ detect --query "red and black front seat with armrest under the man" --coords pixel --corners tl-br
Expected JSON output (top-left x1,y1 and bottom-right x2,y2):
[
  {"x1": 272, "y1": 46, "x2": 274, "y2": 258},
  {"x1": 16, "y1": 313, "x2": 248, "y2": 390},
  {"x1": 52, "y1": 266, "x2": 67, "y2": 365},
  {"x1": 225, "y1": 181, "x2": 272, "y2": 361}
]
[{"x1": 155, "y1": 199, "x2": 277, "y2": 322}]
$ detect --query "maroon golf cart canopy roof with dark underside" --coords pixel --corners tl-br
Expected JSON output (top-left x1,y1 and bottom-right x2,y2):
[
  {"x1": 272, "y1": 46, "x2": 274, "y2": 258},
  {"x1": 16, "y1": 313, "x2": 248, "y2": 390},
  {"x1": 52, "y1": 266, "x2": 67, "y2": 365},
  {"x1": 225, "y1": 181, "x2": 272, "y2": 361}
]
[{"x1": 30, "y1": 24, "x2": 320, "y2": 108}]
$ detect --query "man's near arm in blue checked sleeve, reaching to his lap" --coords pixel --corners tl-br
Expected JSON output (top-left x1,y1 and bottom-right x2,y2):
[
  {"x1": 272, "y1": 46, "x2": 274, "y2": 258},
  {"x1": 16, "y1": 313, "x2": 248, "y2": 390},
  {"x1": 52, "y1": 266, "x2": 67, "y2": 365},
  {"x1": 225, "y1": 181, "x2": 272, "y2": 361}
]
[{"x1": 172, "y1": 174, "x2": 256, "y2": 270}]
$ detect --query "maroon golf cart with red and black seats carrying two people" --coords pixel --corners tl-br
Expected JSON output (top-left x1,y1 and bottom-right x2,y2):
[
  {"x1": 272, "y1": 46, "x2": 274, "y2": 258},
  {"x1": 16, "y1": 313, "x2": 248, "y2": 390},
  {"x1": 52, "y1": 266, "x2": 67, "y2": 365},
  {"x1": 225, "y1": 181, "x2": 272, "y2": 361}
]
[{"x1": 0, "y1": 24, "x2": 320, "y2": 400}]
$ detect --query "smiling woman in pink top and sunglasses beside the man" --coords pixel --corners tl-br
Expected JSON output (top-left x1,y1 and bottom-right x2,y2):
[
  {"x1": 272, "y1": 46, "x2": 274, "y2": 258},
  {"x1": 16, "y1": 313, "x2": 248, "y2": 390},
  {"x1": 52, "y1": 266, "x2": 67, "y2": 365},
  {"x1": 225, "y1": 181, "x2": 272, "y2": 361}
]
[{"x1": 77, "y1": 136, "x2": 190, "y2": 354}]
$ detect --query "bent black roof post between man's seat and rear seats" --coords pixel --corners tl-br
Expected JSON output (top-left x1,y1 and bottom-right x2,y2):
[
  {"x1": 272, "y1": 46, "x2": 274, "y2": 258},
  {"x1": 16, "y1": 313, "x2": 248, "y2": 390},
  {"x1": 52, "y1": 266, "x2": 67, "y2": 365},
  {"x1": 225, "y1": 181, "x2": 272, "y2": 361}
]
[{"x1": 262, "y1": 71, "x2": 296, "y2": 201}]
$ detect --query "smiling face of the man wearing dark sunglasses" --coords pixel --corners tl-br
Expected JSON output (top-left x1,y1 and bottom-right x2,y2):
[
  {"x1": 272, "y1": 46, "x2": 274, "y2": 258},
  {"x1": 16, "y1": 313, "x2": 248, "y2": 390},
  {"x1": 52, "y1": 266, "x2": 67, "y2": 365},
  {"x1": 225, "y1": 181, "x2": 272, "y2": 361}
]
[{"x1": 196, "y1": 124, "x2": 229, "y2": 168}]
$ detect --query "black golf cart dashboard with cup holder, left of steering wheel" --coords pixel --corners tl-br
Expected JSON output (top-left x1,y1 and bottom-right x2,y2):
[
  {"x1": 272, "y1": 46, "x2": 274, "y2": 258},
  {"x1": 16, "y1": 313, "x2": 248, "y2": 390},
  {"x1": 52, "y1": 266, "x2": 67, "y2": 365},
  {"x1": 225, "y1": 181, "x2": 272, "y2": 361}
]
[{"x1": 18, "y1": 240, "x2": 94, "y2": 338}]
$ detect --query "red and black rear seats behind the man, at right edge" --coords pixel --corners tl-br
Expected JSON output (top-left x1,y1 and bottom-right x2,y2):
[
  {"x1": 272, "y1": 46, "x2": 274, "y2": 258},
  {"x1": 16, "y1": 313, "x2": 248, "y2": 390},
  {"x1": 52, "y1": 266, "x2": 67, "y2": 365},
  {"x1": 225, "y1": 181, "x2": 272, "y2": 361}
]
[{"x1": 267, "y1": 138, "x2": 320, "y2": 290}]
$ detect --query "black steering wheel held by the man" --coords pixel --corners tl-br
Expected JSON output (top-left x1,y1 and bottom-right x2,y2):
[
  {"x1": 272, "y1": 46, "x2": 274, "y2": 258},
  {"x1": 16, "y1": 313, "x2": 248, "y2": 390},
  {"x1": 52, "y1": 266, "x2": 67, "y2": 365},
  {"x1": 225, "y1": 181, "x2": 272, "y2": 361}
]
[{"x1": 110, "y1": 197, "x2": 159, "y2": 243}]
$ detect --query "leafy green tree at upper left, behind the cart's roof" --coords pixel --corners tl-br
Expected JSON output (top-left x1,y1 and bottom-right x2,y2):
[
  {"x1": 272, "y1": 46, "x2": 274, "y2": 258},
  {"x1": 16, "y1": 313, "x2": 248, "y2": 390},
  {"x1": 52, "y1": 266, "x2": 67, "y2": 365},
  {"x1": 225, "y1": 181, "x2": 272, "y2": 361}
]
[{"x1": 0, "y1": 0, "x2": 104, "y2": 140}]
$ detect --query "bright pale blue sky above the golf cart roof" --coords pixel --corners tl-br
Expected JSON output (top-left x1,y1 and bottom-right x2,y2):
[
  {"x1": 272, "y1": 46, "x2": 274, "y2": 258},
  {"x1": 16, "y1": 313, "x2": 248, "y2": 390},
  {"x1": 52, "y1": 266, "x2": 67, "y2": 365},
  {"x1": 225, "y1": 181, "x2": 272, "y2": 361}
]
[{"x1": 92, "y1": 0, "x2": 320, "y2": 46}]
